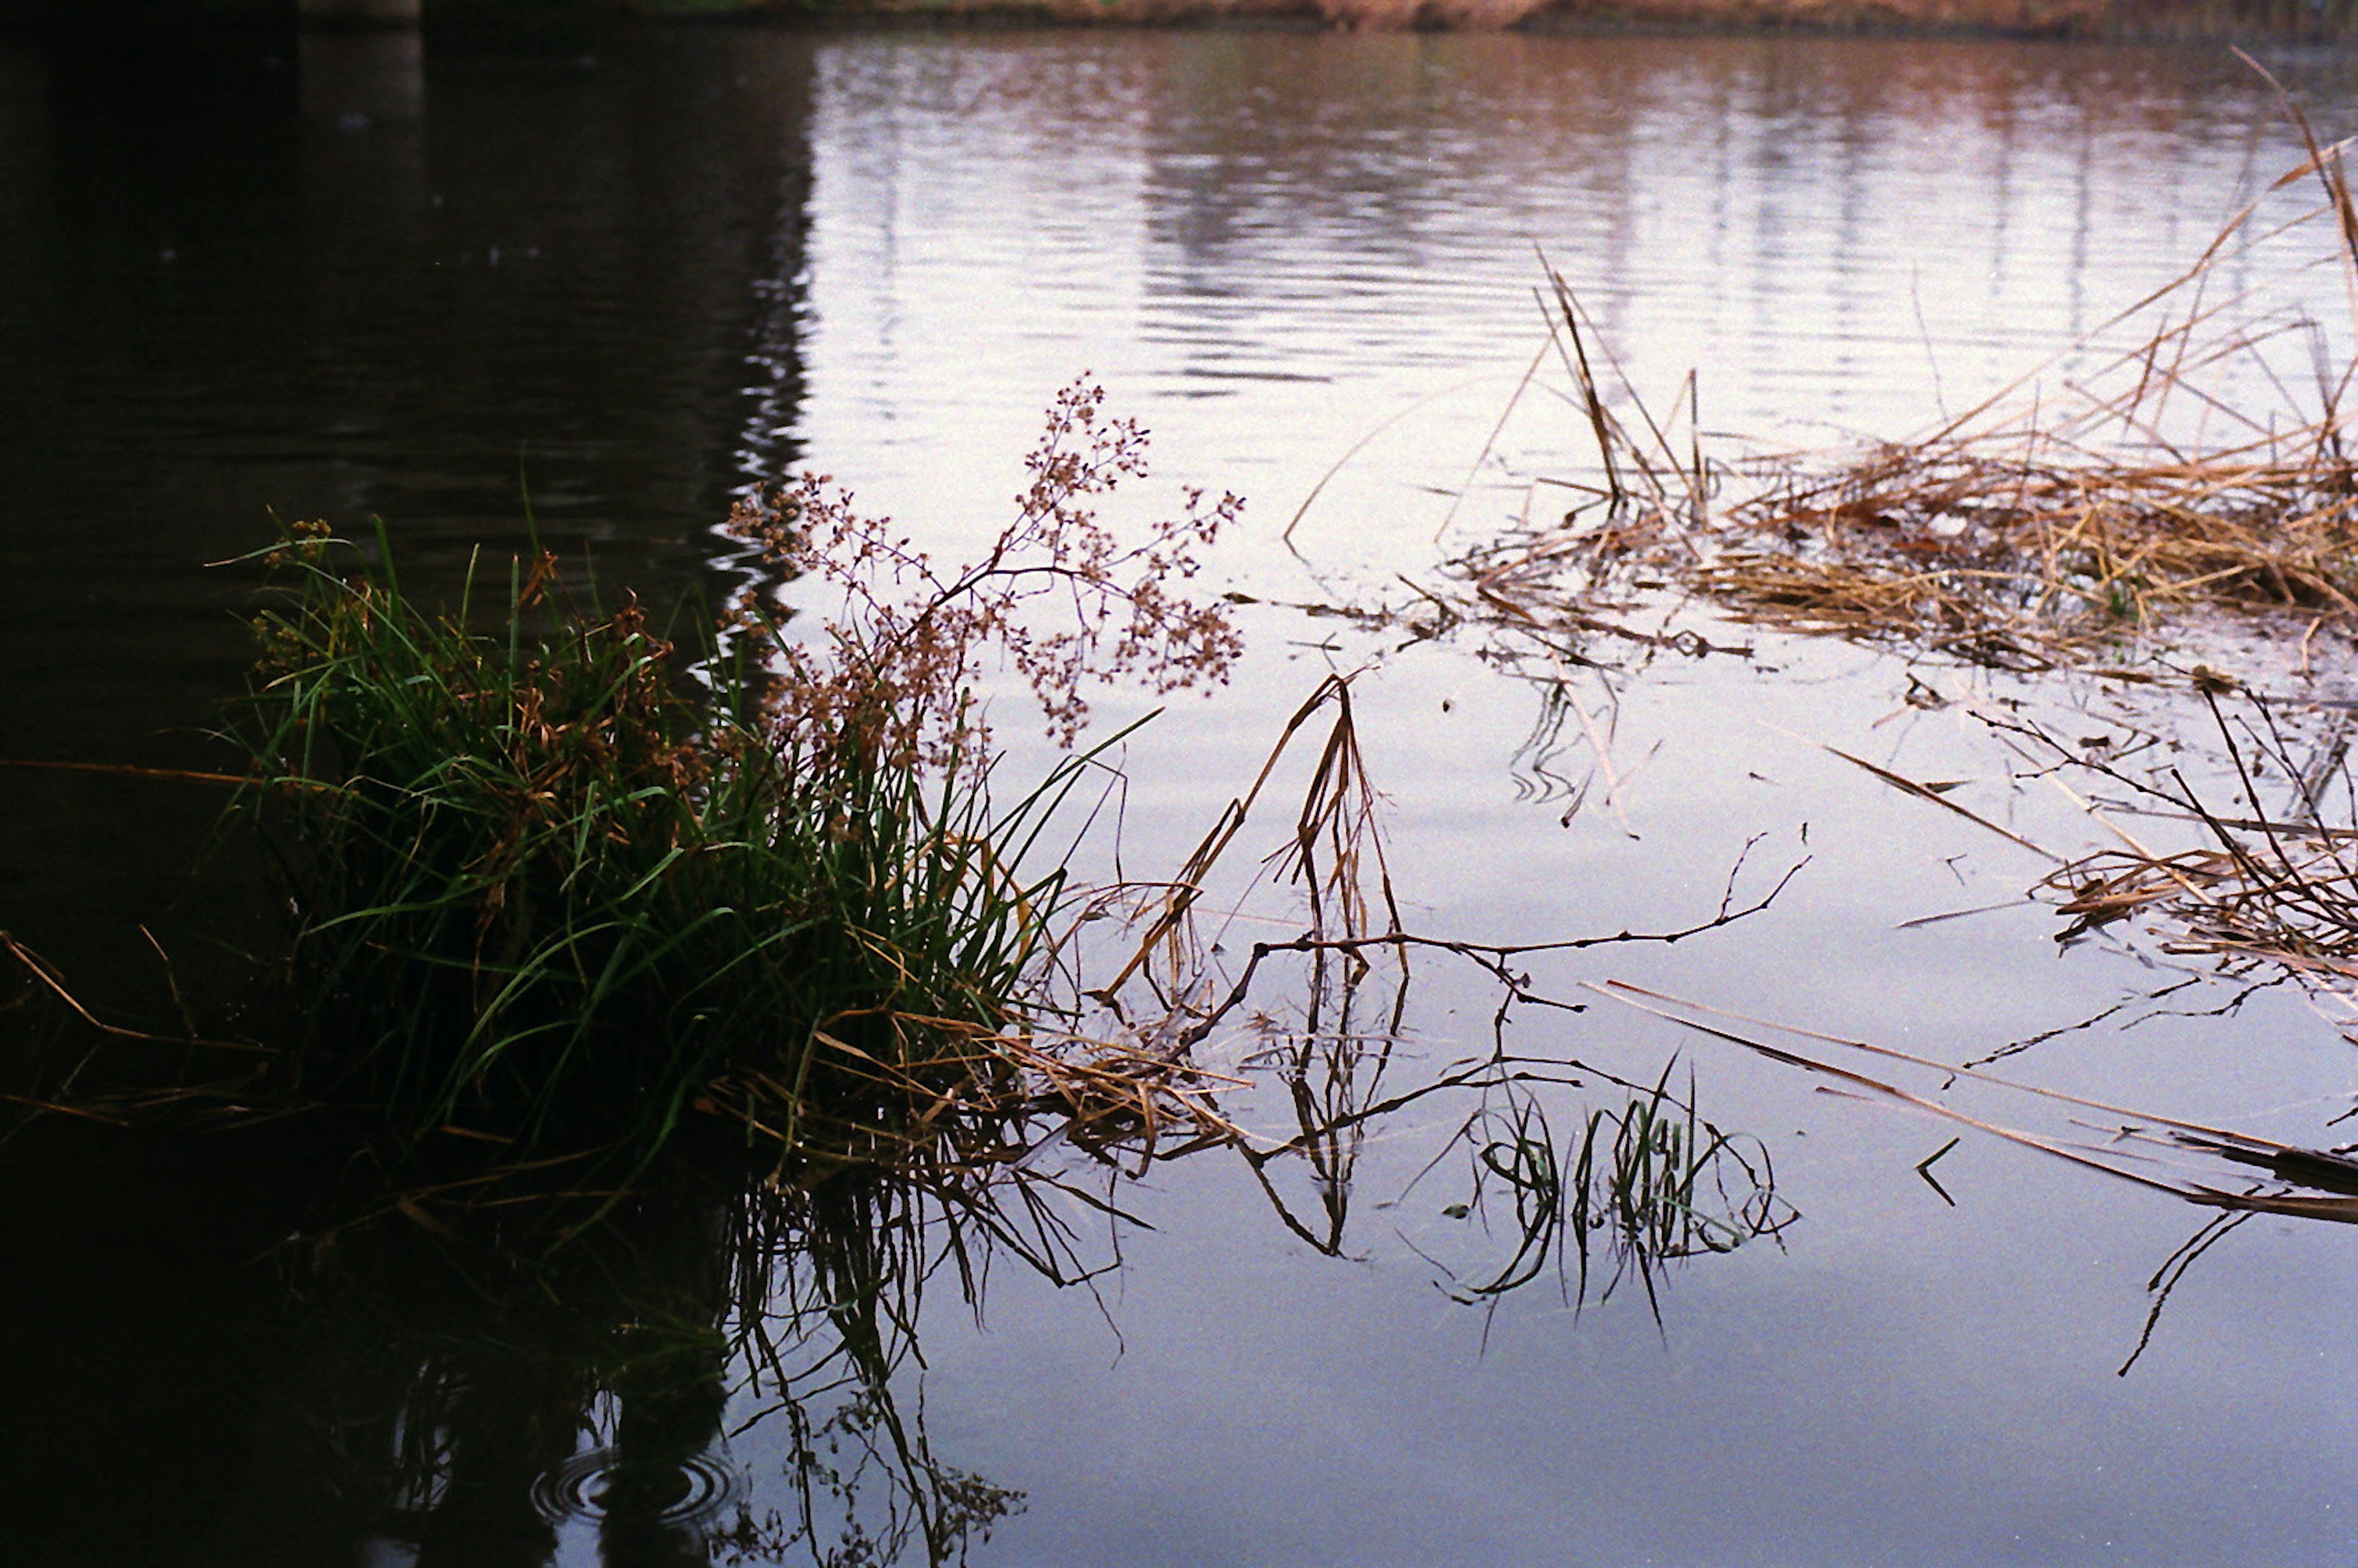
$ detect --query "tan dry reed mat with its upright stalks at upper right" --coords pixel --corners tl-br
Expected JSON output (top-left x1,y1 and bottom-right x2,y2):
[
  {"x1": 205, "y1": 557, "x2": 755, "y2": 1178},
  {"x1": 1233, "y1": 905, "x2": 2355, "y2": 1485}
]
[{"x1": 1455, "y1": 111, "x2": 2358, "y2": 670}]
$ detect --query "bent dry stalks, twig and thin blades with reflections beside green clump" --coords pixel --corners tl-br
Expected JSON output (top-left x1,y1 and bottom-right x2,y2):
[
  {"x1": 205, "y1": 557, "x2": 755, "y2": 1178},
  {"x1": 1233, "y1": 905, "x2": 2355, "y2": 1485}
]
[{"x1": 1150, "y1": 745, "x2": 1799, "y2": 1304}]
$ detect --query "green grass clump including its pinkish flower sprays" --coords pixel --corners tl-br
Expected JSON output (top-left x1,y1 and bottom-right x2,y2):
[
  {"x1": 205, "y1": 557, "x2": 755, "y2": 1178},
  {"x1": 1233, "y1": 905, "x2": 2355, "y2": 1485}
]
[{"x1": 233, "y1": 382, "x2": 1240, "y2": 1148}]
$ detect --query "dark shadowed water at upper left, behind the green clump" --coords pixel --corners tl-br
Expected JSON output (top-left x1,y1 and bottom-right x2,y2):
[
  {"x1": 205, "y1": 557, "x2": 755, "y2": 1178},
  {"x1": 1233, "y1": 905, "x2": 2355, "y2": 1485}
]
[{"x1": 0, "y1": 7, "x2": 814, "y2": 1004}]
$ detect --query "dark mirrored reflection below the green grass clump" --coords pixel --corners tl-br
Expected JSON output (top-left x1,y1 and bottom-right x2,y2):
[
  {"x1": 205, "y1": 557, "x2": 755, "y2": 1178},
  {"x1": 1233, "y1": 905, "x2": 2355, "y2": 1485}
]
[{"x1": 251, "y1": 1151, "x2": 1024, "y2": 1568}]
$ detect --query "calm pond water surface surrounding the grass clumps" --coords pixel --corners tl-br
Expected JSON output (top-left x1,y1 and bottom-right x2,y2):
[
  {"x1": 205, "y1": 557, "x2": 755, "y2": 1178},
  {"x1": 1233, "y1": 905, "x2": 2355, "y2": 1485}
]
[{"x1": 0, "y1": 18, "x2": 2358, "y2": 1566}]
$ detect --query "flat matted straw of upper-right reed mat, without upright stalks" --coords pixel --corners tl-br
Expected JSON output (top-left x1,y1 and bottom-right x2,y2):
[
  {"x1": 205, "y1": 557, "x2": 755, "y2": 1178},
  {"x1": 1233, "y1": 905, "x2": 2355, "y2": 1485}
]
[{"x1": 1686, "y1": 415, "x2": 2358, "y2": 667}]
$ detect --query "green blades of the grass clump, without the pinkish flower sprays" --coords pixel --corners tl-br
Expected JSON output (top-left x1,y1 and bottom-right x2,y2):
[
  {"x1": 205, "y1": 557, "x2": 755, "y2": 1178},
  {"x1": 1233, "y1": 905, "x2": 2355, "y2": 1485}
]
[{"x1": 236, "y1": 530, "x2": 1064, "y2": 1136}]
